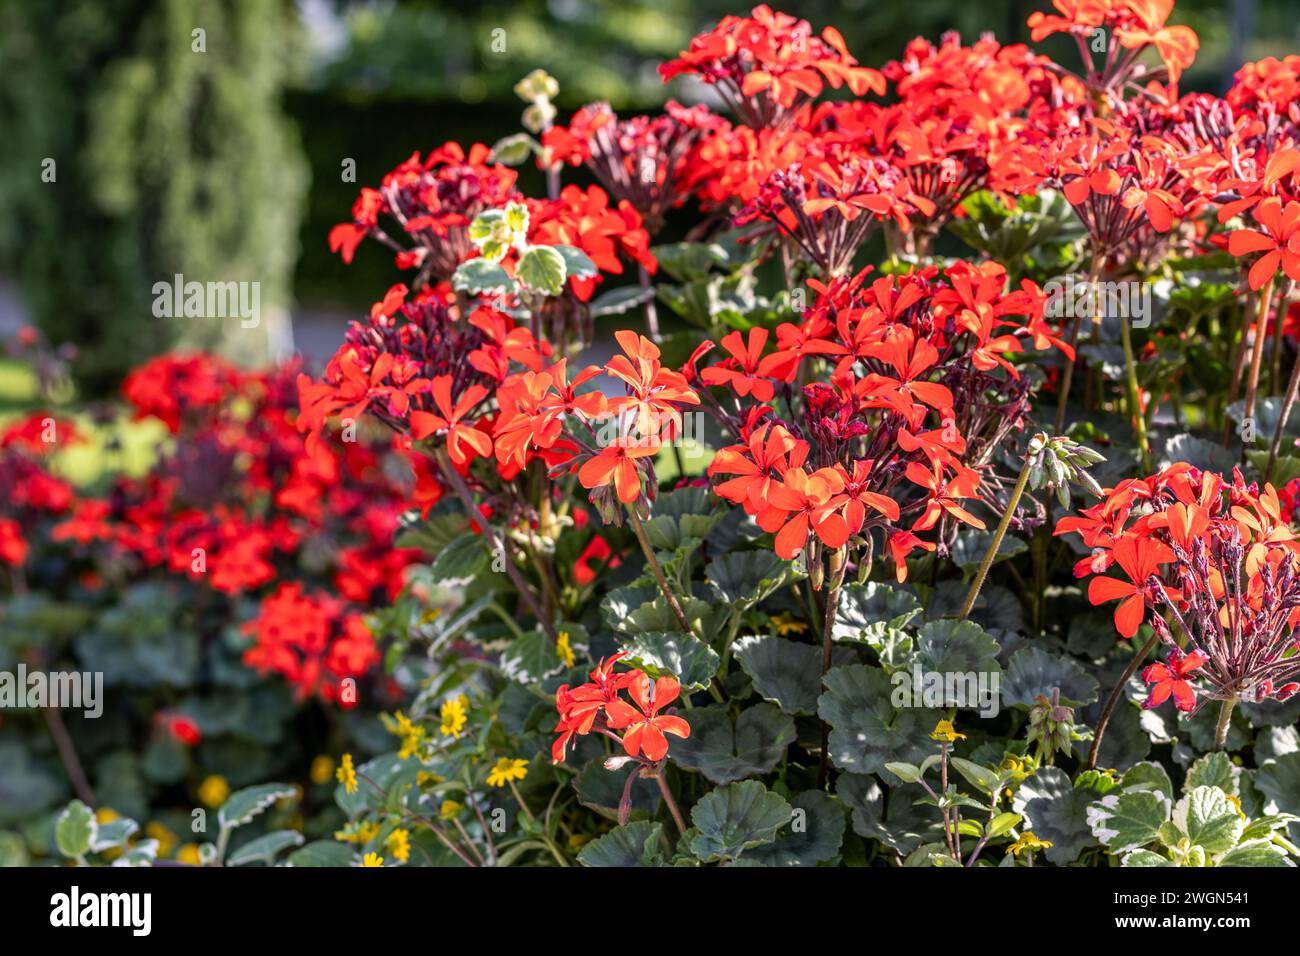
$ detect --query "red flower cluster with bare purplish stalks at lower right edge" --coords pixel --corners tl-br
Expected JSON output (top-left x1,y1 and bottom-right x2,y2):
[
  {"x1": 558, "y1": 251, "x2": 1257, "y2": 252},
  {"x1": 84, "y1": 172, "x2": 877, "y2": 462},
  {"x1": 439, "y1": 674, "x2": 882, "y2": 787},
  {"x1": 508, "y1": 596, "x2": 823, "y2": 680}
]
[{"x1": 1056, "y1": 463, "x2": 1300, "y2": 710}]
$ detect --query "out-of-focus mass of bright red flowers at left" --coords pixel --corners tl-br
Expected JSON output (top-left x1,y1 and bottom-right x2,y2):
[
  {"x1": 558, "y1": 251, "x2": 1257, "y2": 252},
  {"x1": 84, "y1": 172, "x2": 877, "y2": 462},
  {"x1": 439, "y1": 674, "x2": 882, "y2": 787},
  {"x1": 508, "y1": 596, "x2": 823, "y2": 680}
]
[{"x1": 0, "y1": 354, "x2": 420, "y2": 698}]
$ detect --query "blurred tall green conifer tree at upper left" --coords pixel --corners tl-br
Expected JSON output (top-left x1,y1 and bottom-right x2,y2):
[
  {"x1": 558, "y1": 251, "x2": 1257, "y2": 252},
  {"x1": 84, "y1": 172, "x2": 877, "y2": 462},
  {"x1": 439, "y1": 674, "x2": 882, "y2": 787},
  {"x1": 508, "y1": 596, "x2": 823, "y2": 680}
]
[{"x1": 0, "y1": 0, "x2": 308, "y2": 392}]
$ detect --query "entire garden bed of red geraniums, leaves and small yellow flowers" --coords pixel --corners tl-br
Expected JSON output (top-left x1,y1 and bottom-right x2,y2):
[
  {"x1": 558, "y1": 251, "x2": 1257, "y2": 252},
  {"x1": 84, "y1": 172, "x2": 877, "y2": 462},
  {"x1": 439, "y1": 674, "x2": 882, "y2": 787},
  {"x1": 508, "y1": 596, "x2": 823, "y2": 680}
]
[{"x1": 0, "y1": 0, "x2": 1300, "y2": 868}]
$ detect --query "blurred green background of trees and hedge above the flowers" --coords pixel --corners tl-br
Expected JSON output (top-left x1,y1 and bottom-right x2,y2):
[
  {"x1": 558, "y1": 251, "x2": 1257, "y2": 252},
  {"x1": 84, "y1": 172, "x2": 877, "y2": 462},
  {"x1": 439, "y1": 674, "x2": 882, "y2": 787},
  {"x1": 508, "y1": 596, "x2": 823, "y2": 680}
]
[{"x1": 0, "y1": 0, "x2": 1300, "y2": 390}]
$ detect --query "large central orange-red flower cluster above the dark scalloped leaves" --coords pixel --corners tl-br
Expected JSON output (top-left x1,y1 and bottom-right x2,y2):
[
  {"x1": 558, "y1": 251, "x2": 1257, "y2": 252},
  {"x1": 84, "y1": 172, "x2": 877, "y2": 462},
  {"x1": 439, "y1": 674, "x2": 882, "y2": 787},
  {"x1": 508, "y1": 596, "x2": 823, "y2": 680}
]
[{"x1": 690, "y1": 263, "x2": 1063, "y2": 580}]
